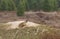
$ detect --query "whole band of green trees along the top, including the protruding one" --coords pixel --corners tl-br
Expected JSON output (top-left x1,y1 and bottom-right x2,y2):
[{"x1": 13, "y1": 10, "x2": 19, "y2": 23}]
[{"x1": 0, "y1": 0, "x2": 58, "y2": 16}]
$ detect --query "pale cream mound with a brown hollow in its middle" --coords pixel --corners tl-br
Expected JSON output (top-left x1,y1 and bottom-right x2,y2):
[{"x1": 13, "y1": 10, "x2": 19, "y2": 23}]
[{"x1": 2, "y1": 21, "x2": 39, "y2": 30}]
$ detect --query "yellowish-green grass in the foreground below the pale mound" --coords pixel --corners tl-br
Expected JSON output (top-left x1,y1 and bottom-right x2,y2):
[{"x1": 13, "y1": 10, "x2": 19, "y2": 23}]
[{"x1": 0, "y1": 24, "x2": 60, "y2": 39}]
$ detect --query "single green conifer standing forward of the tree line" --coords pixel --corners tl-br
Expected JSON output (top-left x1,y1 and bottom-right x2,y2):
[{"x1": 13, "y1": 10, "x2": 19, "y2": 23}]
[{"x1": 17, "y1": 0, "x2": 26, "y2": 16}]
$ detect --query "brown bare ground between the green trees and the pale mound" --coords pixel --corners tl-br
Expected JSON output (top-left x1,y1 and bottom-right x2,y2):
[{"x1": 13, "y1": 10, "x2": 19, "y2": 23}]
[{"x1": 0, "y1": 11, "x2": 60, "y2": 28}]
